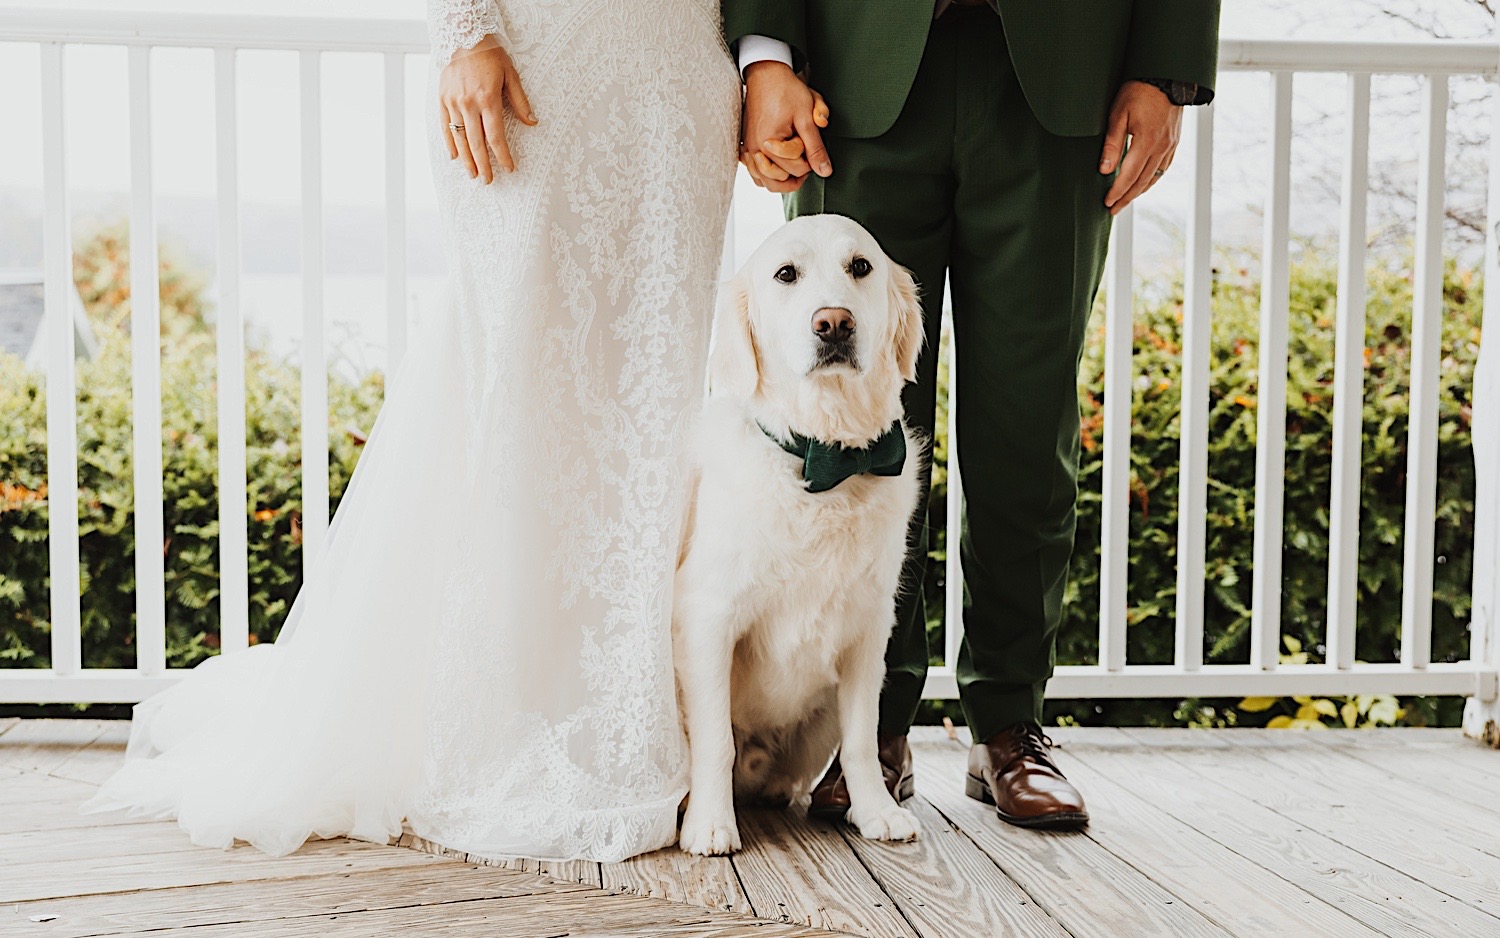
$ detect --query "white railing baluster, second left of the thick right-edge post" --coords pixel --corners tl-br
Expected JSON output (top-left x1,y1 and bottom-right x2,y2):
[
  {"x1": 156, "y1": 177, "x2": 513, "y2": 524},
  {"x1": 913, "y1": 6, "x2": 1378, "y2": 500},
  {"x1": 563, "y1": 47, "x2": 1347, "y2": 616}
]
[{"x1": 1326, "y1": 74, "x2": 1370, "y2": 671}]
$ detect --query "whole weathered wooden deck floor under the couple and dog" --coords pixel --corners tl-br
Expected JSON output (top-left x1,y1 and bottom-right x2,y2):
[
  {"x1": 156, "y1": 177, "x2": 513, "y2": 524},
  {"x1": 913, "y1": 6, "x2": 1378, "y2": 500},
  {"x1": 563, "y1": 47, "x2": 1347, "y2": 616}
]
[{"x1": 0, "y1": 719, "x2": 1500, "y2": 938}]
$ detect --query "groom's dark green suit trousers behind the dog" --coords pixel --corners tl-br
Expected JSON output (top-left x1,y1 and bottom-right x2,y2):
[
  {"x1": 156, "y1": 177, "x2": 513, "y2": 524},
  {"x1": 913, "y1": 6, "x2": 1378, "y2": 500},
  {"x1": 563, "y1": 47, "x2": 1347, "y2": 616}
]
[{"x1": 786, "y1": 6, "x2": 1112, "y2": 740}]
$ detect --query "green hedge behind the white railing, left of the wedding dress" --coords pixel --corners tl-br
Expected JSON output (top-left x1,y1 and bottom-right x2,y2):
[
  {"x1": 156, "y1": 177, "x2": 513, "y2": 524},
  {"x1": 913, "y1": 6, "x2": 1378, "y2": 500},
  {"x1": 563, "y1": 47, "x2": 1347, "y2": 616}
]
[{"x1": 0, "y1": 230, "x2": 396, "y2": 668}]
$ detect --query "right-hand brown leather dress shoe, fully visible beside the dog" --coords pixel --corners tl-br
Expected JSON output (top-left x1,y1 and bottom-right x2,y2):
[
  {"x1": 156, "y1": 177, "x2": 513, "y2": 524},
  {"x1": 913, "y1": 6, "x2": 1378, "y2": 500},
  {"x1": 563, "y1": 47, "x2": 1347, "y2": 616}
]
[{"x1": 965, "y1": 723, "x2": 1089, "y2": 830}]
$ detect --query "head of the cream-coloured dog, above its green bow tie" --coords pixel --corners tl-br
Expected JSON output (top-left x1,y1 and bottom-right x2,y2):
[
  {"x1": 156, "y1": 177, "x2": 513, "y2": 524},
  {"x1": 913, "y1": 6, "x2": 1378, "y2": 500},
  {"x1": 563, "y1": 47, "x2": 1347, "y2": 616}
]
[{"x1": 710, "y1": 215, "x2": 923, "y2": 414}]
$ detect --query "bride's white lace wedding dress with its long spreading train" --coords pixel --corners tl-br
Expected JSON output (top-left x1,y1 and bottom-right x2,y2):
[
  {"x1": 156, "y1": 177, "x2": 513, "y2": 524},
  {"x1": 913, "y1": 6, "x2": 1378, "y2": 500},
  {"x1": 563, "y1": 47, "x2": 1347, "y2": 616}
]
[{"x1": 90, "y1": 0, "x2": 740, "y2": 861}]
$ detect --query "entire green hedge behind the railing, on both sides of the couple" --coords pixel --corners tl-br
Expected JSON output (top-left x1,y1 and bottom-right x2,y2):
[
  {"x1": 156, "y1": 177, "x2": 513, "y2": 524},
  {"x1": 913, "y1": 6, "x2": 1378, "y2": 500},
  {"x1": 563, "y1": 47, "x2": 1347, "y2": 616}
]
[{"x1": 0, "y1": 230, "x2": 1481, "y2": 723}]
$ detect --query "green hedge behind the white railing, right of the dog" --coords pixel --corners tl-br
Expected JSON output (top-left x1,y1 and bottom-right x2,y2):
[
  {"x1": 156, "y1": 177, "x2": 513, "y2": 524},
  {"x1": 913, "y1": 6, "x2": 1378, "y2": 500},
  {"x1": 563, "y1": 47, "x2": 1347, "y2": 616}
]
[{"x1": 927, "y1": 252, "x2": 1481, "y2": 725}]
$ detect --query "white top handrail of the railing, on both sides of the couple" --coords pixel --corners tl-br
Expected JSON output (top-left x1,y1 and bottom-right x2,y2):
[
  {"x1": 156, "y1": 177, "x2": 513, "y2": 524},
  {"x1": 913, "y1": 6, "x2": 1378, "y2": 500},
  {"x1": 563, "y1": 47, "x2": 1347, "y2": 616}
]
[{"x1": 0, "y1": 8, "x2": 1500, "y2": 77}]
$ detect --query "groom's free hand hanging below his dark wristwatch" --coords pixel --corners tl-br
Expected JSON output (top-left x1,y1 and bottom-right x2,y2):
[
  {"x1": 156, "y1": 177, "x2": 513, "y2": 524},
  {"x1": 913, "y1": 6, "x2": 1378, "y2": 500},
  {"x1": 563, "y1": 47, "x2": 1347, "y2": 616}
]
[{"x1": 1100, "y1": 81, "x2": 1182, "y2": 215}]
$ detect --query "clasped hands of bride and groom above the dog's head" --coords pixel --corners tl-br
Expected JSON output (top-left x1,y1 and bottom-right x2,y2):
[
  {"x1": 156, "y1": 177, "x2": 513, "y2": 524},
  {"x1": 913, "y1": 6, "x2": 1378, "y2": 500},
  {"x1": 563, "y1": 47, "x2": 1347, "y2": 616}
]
[{"x1": 740, "y1": 62, "x2": 834, "y2": 192}]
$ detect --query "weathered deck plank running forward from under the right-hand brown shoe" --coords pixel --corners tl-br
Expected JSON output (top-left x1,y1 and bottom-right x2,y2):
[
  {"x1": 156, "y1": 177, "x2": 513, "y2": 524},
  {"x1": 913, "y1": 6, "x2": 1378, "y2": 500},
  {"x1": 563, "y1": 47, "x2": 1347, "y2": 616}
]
[{"x1": 918, "y1": 738, "x2": 1229, "y2": 938}]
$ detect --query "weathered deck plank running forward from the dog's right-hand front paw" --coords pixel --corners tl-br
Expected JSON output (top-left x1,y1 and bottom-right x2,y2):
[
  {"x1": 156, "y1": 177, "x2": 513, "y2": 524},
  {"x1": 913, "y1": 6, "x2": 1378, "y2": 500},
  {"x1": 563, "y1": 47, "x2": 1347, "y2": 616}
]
[{"x1": 845, "y1": 795, "x2": 1068, "y2": 938}]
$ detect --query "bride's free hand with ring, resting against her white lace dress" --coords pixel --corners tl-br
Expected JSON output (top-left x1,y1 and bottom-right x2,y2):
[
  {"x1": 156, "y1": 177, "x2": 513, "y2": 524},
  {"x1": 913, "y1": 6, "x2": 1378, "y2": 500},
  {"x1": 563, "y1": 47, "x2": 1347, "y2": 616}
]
[{"x1": 438, "y1": 36, "x2": 537, "y2": 183}]
